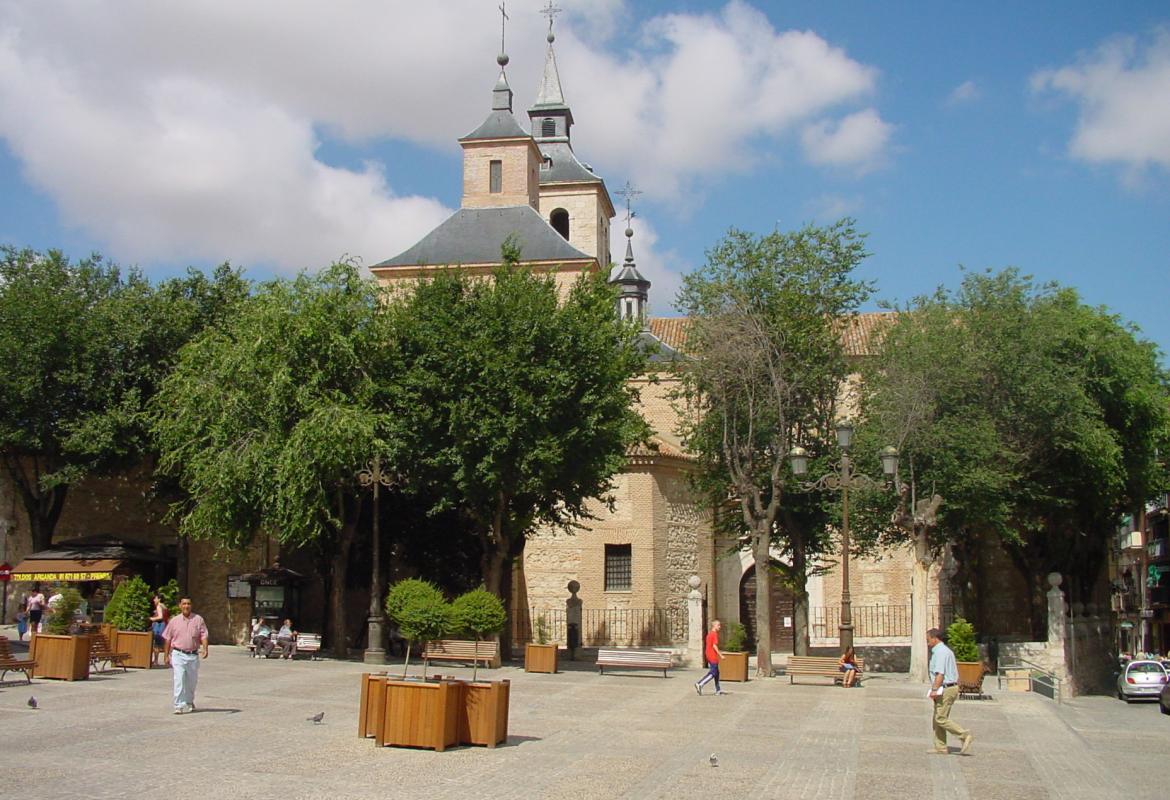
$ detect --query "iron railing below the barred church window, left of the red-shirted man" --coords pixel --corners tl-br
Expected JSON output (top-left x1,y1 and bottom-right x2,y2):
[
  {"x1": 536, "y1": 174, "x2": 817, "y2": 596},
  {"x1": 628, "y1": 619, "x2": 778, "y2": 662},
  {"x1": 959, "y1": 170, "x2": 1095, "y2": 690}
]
[{"x1": 512, "y1": 606, "x2": 687, "y2": 647}]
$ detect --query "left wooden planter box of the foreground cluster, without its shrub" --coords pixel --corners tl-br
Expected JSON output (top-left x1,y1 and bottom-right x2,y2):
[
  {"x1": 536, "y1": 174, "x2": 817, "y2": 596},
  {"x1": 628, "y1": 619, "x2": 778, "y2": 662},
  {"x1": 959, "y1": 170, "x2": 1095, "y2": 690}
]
[{"x1": 371, "y1": 680, "x2": 463, "y2": 752}]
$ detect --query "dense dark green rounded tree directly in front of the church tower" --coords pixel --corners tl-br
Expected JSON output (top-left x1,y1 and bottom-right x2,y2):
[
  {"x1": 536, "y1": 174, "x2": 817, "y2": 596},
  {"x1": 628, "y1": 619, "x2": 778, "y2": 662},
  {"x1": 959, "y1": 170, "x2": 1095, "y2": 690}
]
[{"x1": 394, "y1": 246, "x2": 647, "y2": 654}]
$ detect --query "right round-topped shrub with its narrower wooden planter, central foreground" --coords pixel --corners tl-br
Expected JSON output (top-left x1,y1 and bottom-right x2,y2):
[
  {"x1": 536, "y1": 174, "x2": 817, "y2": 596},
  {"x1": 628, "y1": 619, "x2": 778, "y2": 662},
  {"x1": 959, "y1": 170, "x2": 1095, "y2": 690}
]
[{"x1": 452, "y1": 586, "x2": 511, "y2": 747}]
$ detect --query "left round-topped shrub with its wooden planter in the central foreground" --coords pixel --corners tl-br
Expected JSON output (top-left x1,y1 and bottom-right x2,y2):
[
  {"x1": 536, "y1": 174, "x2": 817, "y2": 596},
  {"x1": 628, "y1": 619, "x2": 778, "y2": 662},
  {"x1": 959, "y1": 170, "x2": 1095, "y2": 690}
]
[{"x1": 379, "y1": 578, "x2": 463, "y2": 751}]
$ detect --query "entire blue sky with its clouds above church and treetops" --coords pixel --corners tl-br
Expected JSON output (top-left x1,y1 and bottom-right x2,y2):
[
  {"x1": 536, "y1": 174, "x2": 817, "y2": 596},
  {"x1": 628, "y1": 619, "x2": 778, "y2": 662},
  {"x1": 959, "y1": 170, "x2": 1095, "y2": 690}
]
[{"x1": 0, "y1": 0, "x2": 1170, "y2": 360}]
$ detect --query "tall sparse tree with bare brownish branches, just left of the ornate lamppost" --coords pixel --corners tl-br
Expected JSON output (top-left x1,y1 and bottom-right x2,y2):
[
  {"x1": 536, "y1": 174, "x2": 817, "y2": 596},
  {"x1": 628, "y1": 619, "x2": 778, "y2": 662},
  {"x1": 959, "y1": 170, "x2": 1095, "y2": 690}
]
[{"x1": 676, "y1": 220, "x2": 869, "y2": 676}]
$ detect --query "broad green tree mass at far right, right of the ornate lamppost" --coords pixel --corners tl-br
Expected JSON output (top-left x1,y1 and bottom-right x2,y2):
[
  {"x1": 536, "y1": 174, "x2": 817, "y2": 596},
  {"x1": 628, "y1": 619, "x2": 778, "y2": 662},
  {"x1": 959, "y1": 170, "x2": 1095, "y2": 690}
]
[{"x1": 865, "y1": 269, "x2": 1170, "y2": 635}]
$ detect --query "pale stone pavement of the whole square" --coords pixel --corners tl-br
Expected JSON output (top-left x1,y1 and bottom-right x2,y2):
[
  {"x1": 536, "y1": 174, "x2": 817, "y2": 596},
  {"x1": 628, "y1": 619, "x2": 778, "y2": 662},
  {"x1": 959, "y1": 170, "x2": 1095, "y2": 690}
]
[{"x1": 0, "y1": 646, "x2": 1170, "y2": 800}]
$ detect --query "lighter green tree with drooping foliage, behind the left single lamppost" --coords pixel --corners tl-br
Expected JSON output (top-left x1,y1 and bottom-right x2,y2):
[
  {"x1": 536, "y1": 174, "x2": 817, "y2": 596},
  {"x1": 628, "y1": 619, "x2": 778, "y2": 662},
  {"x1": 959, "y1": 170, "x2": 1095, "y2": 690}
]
[{"x1": 152, "y1": 263, "x2": 394, "y2": 656}]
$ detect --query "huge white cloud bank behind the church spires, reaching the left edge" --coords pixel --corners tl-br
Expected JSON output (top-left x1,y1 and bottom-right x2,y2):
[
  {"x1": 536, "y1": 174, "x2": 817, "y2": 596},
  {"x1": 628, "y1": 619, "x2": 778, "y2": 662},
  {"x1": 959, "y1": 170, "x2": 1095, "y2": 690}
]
[{"x1": 0, "y1": 0, "x2": 889, "y2": 270}]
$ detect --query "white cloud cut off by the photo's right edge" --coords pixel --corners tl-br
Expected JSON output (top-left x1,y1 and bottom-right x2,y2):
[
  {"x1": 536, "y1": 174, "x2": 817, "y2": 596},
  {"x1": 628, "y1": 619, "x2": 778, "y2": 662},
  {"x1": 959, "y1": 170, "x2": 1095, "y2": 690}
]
[{"x1": 1032, "y1": 30, "x2": 1170, "y2": 172}]
